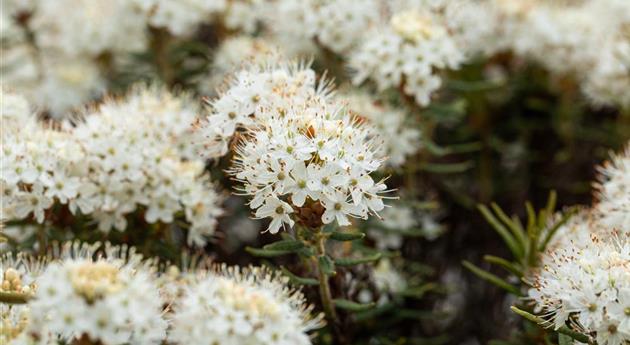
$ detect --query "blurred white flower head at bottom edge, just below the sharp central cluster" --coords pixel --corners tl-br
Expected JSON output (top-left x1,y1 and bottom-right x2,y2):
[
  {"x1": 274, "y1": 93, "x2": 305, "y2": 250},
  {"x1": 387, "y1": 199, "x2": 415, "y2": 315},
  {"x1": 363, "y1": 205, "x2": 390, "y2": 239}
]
[{"x1": 169, "y1": 266, "x2": 322, "y2": 345}]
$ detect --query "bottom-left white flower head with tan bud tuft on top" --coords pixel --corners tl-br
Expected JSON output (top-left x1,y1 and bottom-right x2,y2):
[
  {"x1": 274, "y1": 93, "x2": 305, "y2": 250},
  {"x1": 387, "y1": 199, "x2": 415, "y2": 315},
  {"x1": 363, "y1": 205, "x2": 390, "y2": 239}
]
[{"x1": 27, "y1": 244, "x2": 167, "y2": 344}]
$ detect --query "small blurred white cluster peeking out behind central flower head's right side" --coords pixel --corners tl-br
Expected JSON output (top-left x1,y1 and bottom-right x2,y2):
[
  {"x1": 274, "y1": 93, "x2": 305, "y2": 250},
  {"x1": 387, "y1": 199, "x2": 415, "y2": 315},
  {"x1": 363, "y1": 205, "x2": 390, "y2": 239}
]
[{"x1": 343, "y1": 92, "x2": 422, "y2": 168}]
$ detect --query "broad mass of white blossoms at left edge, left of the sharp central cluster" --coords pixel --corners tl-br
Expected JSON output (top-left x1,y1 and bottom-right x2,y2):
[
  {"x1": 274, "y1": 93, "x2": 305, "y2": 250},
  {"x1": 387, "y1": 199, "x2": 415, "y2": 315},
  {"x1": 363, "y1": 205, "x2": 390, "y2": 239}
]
[{"x1": 0, "y1": 87, "x2": 221, "y2": 245}]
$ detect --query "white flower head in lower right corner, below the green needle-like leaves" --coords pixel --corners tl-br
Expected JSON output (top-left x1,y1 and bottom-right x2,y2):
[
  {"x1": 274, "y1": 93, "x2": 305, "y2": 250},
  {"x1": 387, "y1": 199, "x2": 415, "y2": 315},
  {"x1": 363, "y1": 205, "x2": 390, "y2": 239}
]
[{"x1": 529, "y1": 223, "x2": 630, "y2": 345}]
